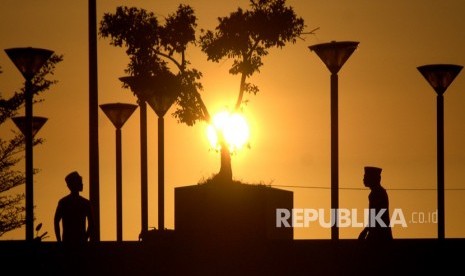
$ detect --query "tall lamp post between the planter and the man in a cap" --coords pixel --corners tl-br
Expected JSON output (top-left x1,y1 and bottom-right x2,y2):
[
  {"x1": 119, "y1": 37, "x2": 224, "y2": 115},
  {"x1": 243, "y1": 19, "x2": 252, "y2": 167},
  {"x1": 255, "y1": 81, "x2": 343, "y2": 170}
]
[{"x1": 309, "y1": 41, "x2": 359, "y2": 240}]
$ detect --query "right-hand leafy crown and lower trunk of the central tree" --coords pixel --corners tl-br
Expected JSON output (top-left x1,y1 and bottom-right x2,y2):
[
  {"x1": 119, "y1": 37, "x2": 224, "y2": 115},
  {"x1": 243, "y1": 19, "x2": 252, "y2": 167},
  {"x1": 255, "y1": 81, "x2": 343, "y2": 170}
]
[{"x1": 200, "y1": 0, "x2": 305, "y2": 181}]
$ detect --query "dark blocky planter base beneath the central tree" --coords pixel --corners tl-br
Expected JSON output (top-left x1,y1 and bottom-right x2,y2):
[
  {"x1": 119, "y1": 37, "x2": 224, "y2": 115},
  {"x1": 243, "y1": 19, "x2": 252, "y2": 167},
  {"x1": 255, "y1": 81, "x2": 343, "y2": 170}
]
[{"x1": 174, "y1": 182, "x2": 294, "y2": 241}]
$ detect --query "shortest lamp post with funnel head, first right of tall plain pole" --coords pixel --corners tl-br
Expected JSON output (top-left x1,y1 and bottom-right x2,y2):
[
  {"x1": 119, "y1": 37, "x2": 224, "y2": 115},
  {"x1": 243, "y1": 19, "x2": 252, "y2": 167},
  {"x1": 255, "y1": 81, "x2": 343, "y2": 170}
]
[{"x1": 100, "y1": 103, "x2": 137, "y2": 242}]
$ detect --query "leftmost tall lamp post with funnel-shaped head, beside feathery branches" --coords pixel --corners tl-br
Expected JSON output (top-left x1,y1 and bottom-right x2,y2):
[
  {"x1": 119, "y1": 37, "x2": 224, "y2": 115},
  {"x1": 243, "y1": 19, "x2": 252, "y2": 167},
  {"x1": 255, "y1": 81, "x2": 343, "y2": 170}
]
[{"x1": 5, "y1": 47, "x2": 53, "y2": 241}]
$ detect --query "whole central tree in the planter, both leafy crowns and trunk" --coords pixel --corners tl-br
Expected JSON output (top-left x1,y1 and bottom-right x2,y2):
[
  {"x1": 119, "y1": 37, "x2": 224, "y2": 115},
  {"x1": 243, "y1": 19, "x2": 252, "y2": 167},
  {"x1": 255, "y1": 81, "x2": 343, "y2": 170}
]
[{"x1": 99, "y1": 0, "x2": 304, "y2": 181}]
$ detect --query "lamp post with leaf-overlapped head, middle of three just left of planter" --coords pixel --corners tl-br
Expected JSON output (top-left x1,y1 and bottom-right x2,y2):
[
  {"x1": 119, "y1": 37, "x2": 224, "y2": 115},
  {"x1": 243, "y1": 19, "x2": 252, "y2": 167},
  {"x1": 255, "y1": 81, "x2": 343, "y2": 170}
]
[{"x1": 119, "y1": 76, "x2": 148, "y2": 234}]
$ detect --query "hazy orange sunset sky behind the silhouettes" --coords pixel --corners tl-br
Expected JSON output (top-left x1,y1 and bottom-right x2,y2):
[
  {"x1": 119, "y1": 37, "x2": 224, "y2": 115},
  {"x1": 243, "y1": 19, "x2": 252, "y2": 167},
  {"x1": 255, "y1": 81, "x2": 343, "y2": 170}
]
[{"x1": 0, "y1": 0, "x2": 465, "y2": 240}]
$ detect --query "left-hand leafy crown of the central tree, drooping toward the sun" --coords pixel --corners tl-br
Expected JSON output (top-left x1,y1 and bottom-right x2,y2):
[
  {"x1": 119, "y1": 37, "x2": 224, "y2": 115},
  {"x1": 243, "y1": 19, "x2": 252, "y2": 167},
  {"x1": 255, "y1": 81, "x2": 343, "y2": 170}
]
[{"x1": 99, "y1": 5, "x2": 208, "y2": 126}]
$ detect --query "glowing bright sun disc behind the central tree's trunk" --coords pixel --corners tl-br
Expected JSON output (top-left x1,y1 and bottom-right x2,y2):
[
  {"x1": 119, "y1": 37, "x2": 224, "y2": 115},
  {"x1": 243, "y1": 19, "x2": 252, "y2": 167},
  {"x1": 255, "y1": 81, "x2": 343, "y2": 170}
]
[{"x1": 207, "y1": 111, "x2": 250, "y2": 152}]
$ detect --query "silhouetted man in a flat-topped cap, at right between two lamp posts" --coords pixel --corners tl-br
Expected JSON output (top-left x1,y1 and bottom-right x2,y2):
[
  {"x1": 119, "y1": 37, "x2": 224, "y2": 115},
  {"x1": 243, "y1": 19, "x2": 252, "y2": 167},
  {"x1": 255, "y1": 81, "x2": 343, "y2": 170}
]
[{"x1": 358, "y1": 167, "x2": 392, "y2": 241}]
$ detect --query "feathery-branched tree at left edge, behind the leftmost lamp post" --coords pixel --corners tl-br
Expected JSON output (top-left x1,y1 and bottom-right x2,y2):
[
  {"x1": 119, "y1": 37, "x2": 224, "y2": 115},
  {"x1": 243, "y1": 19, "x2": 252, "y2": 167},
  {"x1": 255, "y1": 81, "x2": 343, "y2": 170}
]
[{"x1": 0, "y1": 54, "x2": 63, "y2": 236}]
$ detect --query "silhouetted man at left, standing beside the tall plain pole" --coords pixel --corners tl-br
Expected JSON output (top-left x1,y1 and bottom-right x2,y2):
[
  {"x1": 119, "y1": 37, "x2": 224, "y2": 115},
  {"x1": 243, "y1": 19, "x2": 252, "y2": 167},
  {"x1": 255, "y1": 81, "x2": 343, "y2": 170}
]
[{"x1": 54, "y1": 171, "x2": 94, "y2": 245}]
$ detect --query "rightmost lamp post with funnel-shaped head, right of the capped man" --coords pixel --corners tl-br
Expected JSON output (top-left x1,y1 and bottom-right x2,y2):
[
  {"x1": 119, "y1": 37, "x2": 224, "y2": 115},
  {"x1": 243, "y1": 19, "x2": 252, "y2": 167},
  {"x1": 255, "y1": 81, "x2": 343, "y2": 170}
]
[{"x1": 417, "y1": 64, "x2": 463, "y2": 239}]
